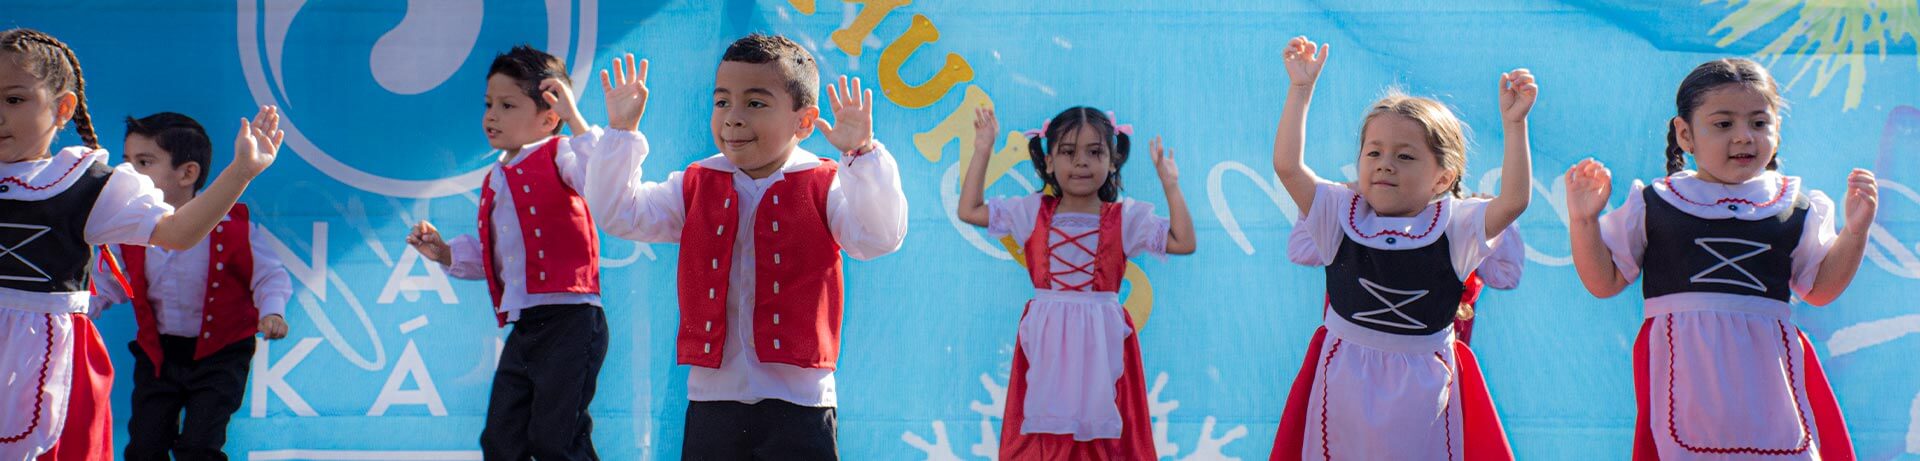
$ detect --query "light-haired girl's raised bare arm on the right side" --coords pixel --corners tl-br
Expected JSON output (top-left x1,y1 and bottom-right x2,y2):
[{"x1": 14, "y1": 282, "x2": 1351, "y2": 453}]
[{"x1": 1486, "y1": 69, "x2": 1540, "y2": 238}]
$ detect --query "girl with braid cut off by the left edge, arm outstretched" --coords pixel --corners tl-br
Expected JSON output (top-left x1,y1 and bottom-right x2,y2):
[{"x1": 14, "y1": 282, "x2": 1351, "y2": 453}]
[{"x1": 0, "y1": 29, "x2": 282, "y2": 461}]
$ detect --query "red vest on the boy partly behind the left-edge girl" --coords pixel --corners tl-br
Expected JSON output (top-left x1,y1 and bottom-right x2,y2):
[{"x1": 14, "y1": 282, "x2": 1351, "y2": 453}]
[{"x1": 121, "y1": 204, "x2": 259, "y2": 375}]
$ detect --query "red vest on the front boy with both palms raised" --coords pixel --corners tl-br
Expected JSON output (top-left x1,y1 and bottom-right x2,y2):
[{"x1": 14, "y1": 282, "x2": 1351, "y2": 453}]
[{"x1": 676, "y1": 159, "x2": 841, "y2": 369}]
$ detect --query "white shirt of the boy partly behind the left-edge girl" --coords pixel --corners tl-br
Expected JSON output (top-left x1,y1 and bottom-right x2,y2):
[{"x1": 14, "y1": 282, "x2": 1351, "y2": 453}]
[{"x1": 92, "y1": 219, "x2": 294, "y2": 338}]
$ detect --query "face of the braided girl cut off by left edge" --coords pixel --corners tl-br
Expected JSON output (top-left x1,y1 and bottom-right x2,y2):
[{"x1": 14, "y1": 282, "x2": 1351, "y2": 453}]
[{"x1": 0, "y1": 52, "x2": 79, "y2": 163}]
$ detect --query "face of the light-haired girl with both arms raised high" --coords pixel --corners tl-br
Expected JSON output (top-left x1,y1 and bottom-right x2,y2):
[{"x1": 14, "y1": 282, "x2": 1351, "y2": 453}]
[{"x1": 1354, "y1": 113, "x2": 1453, "y2": 217}]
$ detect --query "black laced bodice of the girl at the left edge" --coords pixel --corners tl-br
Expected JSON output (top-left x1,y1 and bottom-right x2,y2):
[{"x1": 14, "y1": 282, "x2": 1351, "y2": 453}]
[{"x1": 0, "y1": 163, "x2": 113, "y2": 292}]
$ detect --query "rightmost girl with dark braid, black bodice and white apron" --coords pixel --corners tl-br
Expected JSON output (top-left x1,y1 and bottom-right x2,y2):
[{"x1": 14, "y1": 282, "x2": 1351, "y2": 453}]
[{"x1": 1567, "y1": 58, "x2": 1880, "y2": 461}]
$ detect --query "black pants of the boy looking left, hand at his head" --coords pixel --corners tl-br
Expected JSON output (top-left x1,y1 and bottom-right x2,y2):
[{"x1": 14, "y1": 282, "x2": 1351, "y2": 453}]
[{"x1": 480, "y1": 303, "x2": 607, "y2": 461}]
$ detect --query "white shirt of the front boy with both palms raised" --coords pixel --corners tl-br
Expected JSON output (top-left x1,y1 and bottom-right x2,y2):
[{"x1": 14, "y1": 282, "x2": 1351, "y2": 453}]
[{"x1": 588, "y1": 140, "x2": 906, "y2": 407}]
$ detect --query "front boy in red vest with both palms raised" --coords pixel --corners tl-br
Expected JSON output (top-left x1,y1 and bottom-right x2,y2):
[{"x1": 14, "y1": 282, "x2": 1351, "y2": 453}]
[{"x1": 588, "y1": 35, "x2": 906, "y2": 459}]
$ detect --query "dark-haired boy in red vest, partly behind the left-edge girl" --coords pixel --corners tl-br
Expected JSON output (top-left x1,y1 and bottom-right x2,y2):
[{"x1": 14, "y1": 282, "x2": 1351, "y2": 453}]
[{"x1": 92, "y1": 111, "x2": 294, "y2": 461}]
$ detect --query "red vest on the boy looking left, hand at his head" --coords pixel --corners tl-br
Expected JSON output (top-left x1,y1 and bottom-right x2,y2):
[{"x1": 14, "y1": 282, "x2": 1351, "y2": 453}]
[{"x1": 480, "y1": 136, "x2": 599, "y2": 327}]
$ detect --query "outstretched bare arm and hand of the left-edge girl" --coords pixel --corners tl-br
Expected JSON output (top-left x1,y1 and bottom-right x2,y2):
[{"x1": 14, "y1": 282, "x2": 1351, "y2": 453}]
[{"x1": 150, "y1": 106, "x2": 286, "y2": 252}]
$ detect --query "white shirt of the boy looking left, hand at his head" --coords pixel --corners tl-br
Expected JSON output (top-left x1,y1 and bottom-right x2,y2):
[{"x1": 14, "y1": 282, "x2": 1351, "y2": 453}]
[{"x1": 447, "y1": 127, "x2": 645, "y2": 321}]
